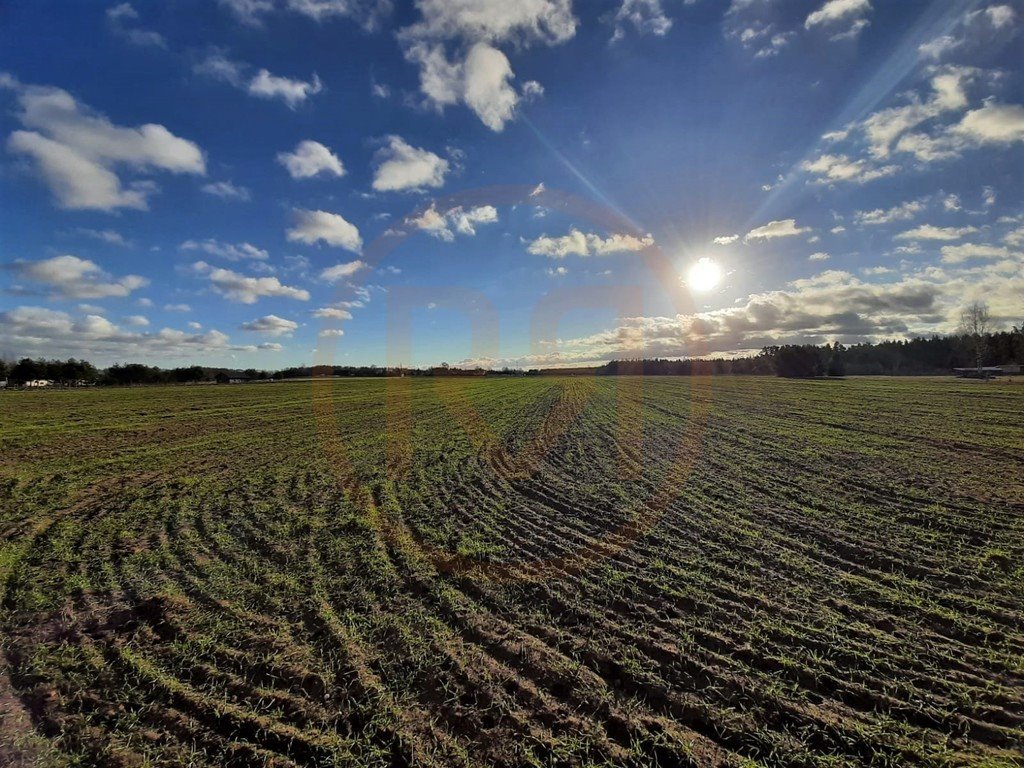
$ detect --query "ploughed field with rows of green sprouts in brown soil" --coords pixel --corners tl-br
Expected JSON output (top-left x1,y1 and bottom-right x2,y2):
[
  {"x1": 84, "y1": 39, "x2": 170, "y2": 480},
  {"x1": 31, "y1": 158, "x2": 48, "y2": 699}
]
[{"x1": 0, "y1": 378, "x2": 1024, "y2": 767}]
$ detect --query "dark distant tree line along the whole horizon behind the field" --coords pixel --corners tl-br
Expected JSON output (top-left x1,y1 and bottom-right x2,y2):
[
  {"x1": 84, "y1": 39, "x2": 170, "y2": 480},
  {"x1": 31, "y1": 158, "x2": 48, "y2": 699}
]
[{"x1": 0, "y1": 323, "x2": 1024, "y2": 386}]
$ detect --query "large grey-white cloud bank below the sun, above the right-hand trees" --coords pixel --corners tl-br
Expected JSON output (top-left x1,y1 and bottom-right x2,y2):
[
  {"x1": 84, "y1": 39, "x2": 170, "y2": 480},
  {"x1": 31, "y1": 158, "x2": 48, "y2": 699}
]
[{"x1": 460, "y1": 259, "x2": 1024, "y2": 367}]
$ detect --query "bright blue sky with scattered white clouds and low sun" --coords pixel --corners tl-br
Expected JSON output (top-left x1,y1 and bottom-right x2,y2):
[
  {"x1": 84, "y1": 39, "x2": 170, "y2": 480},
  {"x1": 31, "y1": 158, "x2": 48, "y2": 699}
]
[{"x1": 0, "y1": 0, "x2": 1024, "y2": 369}]
